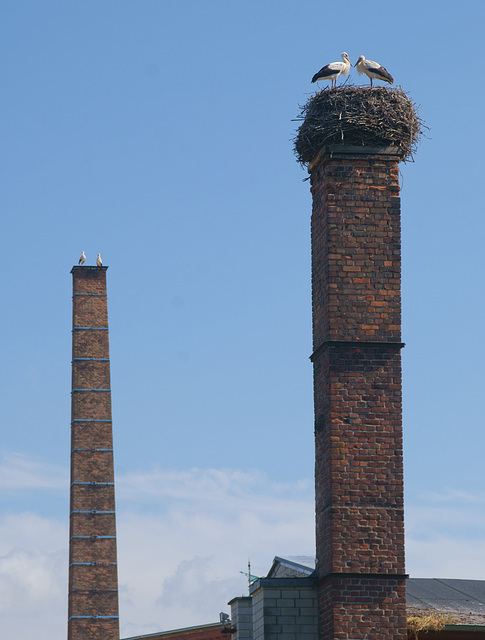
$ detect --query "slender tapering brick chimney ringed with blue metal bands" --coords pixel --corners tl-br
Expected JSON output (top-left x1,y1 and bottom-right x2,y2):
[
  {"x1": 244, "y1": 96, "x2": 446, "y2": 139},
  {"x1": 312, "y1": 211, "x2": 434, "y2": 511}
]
[{"x1": 68, "y1": 266, "x2": 120, "y2": 640}]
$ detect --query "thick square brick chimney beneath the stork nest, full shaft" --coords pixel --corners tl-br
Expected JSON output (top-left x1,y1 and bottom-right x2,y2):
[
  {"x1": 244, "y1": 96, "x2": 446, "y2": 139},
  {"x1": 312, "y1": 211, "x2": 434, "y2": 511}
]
[{"x1": 311, "y1": 151, "x2": 406, "y2": 640}]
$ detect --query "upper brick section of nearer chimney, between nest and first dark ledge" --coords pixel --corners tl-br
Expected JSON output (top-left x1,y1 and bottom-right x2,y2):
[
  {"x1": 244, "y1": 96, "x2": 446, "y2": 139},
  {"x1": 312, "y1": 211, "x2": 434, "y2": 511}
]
[{"x1": 312, "y1": 158, "x2": 401, "y2": 346}]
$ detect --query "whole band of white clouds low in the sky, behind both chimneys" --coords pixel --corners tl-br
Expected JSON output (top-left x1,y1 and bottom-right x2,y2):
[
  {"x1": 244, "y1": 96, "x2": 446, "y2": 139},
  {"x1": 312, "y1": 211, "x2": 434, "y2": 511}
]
[{"x1": 0, "y1": 456, "x2": 485, "y2": 640}]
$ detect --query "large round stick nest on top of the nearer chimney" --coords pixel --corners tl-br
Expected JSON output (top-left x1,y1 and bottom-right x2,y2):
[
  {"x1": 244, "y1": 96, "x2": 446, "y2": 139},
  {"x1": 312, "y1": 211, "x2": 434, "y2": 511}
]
[{"x1": 294, "y1": 85, "x2": 425, "y2": 165}]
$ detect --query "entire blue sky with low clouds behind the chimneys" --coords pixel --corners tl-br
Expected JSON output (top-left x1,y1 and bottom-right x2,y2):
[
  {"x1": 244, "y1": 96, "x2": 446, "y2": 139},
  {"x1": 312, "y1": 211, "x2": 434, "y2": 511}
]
[{"x1": 0, "y1": 0, "x2": 485, "y2": 640}]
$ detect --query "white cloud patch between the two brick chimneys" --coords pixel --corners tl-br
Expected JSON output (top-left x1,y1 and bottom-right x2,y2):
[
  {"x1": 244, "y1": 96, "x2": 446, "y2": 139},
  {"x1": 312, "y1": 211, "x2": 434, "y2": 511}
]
[{"x1": 118, "y1": 469, "x2": 314, "y2": 635}]
